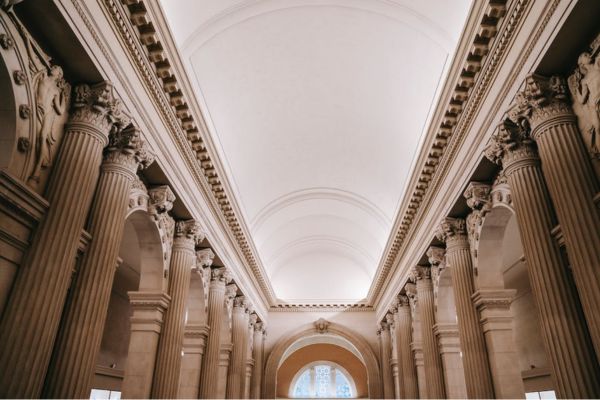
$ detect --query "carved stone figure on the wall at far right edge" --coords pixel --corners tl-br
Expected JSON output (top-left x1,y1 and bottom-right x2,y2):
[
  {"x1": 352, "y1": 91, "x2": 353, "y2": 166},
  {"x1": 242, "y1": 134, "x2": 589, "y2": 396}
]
[{"x1": 568, "y1": 36, "x2": 600, "y2": 167}]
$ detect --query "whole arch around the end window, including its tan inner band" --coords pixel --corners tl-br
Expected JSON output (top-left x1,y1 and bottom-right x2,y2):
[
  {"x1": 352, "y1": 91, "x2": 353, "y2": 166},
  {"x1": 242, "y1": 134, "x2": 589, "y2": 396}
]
[{"x1": 263, "y1": 320, "x2": 381, "y2": 398}]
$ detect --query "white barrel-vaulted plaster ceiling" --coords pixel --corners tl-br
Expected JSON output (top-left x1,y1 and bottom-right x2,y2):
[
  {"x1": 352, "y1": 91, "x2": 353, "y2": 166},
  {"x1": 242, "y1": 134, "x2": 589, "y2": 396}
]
[{"x1": 161, "y1": 0, "x2": 470, "y2": 302}]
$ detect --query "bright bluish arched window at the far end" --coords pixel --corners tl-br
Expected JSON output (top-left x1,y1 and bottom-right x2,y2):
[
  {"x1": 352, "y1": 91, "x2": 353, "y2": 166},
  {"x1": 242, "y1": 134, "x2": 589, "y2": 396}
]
[{"x1": 288, "y1": 360, "x2": 357, "y2": 399}]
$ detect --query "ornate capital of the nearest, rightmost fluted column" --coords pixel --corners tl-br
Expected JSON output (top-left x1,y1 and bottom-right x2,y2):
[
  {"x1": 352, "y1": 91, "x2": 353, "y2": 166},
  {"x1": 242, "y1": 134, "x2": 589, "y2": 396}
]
[{"x1": 508, "y1": 74, "x2": 573, "y2": 134}]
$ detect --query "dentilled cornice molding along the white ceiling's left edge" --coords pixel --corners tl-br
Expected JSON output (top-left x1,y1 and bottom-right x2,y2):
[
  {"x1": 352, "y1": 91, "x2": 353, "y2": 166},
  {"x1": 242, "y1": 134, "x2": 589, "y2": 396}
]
[{"x1": 94, "y1": 0, "x2": 275, "y2": 305}]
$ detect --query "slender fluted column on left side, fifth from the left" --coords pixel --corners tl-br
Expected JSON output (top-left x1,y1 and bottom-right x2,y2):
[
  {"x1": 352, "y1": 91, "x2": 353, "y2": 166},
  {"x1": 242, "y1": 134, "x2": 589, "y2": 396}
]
[{"x1": 227, "y1": 296, "x2": 249, "y2": 399}]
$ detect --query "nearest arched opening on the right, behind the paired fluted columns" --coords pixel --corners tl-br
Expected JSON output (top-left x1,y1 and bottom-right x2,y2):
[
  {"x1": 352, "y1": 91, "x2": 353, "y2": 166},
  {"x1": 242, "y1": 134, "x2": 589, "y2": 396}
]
[{"x1": 475, "y1": 202, "x2": 554, "y2": 392}]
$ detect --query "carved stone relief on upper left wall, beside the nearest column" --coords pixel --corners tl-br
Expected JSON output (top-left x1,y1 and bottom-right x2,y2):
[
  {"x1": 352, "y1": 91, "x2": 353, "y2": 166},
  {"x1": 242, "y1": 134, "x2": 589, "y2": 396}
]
[{"x1": 0, "y1": 7, "x2": 71, "y2": 193}]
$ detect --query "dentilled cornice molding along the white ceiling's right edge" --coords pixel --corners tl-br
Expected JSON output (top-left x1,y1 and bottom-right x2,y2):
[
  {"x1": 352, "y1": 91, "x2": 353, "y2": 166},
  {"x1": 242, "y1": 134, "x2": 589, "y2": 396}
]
[{"x1": 368, "y1": 0, "x2": 508, "y2": 303}]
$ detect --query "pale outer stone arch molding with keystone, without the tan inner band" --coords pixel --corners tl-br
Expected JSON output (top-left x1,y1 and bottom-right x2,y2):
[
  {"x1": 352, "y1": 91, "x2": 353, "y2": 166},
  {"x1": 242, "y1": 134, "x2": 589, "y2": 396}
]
[{"x1": 262, "y1": 322, "x2": 382, "y2": 398}]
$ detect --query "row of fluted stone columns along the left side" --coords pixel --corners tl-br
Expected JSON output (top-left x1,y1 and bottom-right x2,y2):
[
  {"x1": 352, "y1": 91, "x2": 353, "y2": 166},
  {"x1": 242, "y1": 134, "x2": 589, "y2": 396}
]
[{"x1": 0, "y1": 82, "x2": 264, "y2": 398}]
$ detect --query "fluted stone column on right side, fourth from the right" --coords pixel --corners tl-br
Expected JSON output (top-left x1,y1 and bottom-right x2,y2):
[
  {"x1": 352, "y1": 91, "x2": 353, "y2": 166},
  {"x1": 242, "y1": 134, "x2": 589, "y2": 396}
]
[{"x1": 416, "y1": 266, "x2": 445, "y2": 399}]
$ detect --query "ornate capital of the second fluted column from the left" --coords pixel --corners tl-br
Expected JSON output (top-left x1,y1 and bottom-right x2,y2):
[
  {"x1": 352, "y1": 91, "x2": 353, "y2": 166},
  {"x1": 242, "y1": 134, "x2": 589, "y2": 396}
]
[{"x1": 104, "y1": 125, "x2": 154, "y2": 174}]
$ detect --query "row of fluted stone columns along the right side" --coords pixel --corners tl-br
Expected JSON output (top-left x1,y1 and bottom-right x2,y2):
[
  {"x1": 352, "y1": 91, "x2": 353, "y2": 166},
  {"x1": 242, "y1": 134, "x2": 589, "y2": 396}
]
[{"x1": 380, "y1": 75, "x2": 600, "y2": 398}]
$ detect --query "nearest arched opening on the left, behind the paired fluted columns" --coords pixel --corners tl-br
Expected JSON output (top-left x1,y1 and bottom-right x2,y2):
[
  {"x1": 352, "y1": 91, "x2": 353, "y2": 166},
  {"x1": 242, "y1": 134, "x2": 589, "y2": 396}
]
[{"x1": 92, "y1": 210, "x2": 164, "y2": 392}]
